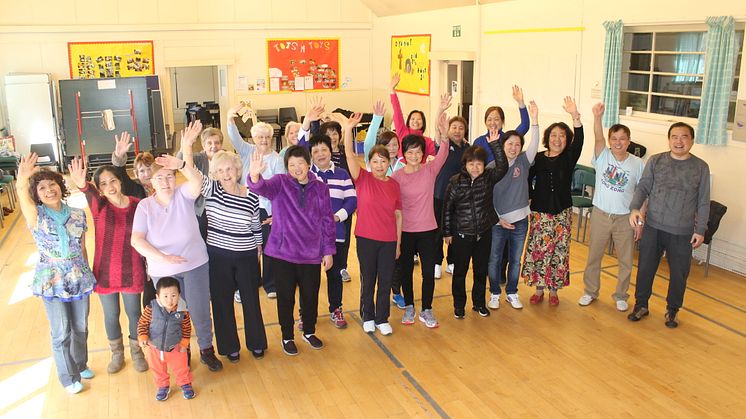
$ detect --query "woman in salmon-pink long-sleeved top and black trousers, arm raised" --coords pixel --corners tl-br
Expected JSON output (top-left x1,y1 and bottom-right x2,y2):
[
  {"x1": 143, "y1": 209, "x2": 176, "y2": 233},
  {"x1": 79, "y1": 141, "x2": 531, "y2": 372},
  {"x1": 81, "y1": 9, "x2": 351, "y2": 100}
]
[{"x1": 392, "y1": 113, "x2": 449, "y2": 328}]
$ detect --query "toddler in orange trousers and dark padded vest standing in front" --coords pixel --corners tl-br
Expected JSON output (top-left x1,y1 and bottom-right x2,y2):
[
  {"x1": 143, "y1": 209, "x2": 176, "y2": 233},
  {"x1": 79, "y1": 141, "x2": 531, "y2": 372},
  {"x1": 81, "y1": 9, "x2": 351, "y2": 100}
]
[{"x1": 137, "y1": 276, "x2": 196, "y2": 401}]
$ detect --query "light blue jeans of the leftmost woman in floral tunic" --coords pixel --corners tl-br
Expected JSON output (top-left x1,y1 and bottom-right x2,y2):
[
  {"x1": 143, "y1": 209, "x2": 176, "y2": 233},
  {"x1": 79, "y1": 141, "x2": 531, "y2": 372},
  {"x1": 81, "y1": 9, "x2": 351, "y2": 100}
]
[{"x1": 43, "y1": 295, "x2": 90, "y2": 387}]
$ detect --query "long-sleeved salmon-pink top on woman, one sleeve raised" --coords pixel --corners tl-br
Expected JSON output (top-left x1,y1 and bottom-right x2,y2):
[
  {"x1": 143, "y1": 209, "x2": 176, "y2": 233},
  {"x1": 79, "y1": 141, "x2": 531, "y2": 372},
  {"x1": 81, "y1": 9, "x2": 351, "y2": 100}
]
[{"x1": 390, "y1": 140, "x2": 449, "y2": 233}]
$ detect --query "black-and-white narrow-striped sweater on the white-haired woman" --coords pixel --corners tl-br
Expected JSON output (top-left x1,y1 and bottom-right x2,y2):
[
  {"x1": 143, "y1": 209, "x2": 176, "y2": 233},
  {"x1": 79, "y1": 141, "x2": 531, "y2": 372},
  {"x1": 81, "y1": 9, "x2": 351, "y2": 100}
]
[{"x1": 202, "y1": 175, "x2": 262, "y2": 252}]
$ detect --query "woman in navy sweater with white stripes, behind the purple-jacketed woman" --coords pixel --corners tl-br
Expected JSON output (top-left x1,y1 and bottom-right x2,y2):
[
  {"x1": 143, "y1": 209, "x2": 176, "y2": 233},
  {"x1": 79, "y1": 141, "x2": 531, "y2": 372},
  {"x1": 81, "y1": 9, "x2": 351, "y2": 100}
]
[{"x1": 308, "y1": 134, "x2": 357, "y2": 329}]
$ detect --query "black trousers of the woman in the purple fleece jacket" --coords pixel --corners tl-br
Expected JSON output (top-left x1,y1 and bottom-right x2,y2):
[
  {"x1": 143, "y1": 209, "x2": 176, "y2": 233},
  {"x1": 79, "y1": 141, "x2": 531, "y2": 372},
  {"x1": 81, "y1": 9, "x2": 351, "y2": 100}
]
[{"x1": 270, "y1": 257, "x2": 321, "y2": 340}]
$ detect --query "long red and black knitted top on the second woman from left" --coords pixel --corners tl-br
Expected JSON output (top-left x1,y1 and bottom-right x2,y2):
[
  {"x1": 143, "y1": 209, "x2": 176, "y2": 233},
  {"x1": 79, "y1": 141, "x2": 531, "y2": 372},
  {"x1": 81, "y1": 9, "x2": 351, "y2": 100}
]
[{"x1": 81, "y1": 183, "x2": 145, "y2": 294}]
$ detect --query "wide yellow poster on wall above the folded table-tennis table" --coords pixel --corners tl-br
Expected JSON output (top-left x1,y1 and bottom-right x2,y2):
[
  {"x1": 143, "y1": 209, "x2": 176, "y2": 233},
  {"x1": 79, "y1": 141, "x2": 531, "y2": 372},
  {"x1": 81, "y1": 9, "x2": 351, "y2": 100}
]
[{"x1": 67, "y1": 41, "x2": 155, "y2": 79}]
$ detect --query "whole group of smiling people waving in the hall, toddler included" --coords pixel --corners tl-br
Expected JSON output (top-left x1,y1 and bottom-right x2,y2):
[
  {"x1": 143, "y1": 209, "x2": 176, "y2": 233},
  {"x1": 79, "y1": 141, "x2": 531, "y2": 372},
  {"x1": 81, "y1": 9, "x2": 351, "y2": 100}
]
[{"x1": 17, "y1": 76, "x2": 709, "y2": 400}]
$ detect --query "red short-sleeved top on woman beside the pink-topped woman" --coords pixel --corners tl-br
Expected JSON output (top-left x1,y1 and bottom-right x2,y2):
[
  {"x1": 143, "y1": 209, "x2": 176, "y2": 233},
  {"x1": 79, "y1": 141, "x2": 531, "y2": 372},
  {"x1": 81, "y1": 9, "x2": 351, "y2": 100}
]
[{"x1": 355, "y1": 170, "x2": 401, "y2": 242}]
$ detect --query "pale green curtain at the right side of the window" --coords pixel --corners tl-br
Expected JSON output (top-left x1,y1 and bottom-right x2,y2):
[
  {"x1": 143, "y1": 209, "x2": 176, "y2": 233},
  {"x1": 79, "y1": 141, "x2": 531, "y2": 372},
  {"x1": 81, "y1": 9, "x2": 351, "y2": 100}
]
[{"x1": 696, "y1": 16, "x2": 738, "y2": 145}]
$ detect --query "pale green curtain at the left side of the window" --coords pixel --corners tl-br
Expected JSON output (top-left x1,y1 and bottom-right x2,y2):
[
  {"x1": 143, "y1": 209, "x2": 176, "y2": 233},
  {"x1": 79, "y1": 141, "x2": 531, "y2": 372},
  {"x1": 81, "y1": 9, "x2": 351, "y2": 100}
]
[{"x1": 601, "y1": 20, "x2": 624, "y2": 127}]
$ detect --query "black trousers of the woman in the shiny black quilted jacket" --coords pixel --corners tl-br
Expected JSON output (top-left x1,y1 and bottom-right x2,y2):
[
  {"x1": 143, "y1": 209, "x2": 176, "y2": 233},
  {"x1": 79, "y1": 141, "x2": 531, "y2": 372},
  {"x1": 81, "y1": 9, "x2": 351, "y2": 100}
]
[{"x1": 451, "y1": 230, "x2": 492, "y2": 308}]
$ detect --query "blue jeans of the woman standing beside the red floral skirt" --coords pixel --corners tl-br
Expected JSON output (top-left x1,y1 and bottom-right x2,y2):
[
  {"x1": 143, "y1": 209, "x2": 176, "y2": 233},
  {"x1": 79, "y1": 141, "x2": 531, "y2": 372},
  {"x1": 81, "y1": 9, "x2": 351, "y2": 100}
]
[{"x1": 487, "y1": 217, "x2": 528, "y2": 294}]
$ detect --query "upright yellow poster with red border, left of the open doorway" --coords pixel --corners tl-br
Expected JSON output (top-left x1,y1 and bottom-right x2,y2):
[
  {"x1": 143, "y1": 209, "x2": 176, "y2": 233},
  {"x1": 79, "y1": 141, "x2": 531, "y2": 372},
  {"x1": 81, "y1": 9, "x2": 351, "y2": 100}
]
[{"x1": 391, "y1": 35, "x2": 430, "y2": 96}]
